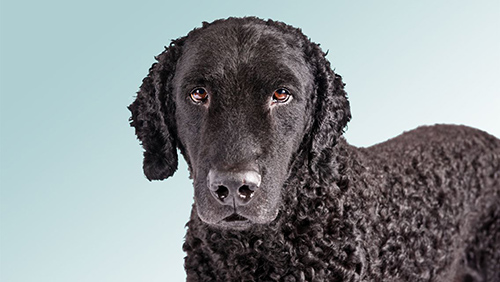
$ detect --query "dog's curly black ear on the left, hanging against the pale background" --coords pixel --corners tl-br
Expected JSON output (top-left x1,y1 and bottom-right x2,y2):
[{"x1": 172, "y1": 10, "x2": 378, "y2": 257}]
[{"x1": 128, "y1": 39, "x2": 183, "y2": 180}]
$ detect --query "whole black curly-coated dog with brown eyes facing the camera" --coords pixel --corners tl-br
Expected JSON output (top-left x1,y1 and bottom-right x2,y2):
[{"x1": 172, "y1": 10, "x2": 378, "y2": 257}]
[{"x1": 129, "y1": 18, "x2": 500, "y2": 281}]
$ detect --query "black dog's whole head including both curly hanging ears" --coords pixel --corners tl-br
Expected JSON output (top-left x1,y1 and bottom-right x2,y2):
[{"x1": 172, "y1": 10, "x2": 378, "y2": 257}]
[{"x1": 129, "y1": 18, "x2": 350, "y2": 229}]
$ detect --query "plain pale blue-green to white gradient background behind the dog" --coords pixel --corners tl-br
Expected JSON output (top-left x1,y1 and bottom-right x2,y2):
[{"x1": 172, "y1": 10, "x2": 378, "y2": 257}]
[{"x1": 0, "y1": 0, "x2": 500, "y2": 282}]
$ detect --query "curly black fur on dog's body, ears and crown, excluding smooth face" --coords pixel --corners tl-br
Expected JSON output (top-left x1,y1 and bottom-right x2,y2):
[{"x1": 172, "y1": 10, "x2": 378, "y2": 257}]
[{"x1": 129, "y1": 18, "x2": 500, "y2": 281}]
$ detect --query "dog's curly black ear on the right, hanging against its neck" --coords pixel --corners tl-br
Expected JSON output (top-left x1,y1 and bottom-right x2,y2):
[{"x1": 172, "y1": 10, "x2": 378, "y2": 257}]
[{"x1": 309, "y1": 44, "x2": 351, "y2": 184}]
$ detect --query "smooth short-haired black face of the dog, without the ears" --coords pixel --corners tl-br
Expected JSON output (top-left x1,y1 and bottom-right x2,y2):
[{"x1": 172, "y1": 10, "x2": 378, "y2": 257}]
[{"x1": 173, "y1": 22, "x2": 314, "y2": 228}]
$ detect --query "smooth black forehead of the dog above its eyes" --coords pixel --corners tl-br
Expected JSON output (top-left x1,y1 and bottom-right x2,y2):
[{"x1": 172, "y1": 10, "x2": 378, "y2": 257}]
[{"x1": 176, "y1": 24, "x2": 310, "y2": 94}]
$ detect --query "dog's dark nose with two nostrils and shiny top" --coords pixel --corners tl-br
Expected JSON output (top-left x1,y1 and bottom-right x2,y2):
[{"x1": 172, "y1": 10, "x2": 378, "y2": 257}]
[{"x1": 207, "y1": 170, "x2": 261, "y2": 206}]
